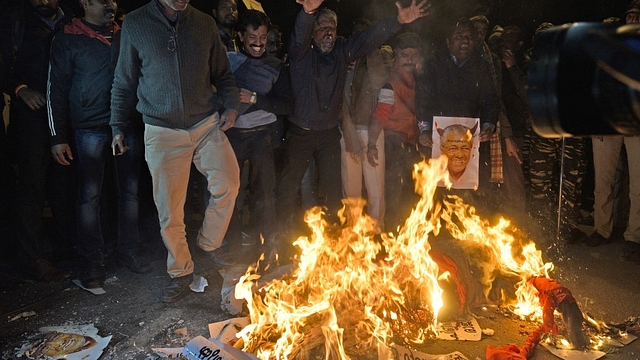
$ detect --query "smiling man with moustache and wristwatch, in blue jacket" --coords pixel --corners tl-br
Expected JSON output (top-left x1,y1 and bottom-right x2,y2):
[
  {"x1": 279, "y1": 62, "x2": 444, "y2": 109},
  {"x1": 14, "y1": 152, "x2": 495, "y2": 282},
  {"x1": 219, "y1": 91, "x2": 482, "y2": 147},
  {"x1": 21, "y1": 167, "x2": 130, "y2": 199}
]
[{"x1": 226, "y1": 10, "x2": 292, "y2": 253}]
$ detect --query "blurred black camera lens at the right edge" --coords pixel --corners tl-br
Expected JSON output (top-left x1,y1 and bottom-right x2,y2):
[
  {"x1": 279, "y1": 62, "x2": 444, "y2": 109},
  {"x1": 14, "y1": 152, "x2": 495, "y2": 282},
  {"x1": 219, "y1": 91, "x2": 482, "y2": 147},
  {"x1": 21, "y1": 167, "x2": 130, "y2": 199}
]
[{"x1": 528, "y1": 23, "x2": 640, "y2": 138}]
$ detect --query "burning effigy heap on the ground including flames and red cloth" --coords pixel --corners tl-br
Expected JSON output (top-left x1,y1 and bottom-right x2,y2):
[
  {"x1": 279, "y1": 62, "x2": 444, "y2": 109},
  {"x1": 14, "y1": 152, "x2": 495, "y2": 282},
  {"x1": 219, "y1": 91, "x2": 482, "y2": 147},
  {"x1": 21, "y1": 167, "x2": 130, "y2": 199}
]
[{"x1": 235, "y1": 157, "x2": 632, "y2": 360}]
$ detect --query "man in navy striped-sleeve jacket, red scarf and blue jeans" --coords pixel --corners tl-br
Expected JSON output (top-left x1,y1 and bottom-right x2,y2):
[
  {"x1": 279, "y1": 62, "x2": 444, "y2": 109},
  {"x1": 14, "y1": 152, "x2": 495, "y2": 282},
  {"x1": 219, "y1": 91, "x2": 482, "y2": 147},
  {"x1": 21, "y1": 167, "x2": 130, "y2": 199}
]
[{"x1": 47, "y1": 0, "x2": 151, "y2": 289}]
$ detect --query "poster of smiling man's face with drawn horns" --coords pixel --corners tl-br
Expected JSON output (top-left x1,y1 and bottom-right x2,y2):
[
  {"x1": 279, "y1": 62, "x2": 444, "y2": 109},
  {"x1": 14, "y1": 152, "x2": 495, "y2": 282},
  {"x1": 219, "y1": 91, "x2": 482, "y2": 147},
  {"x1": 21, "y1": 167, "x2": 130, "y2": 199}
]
[{"x1": 432, "y1": 116, "x2": 480, "y2": 190}]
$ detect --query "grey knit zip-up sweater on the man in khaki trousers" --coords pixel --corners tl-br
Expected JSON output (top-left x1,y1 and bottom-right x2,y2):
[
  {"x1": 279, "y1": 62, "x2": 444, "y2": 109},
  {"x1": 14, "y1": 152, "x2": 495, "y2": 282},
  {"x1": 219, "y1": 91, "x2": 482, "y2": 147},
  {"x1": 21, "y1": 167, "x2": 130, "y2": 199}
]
[{"x1": 110, "y1": 0, "x2": 239, "y2": 136}]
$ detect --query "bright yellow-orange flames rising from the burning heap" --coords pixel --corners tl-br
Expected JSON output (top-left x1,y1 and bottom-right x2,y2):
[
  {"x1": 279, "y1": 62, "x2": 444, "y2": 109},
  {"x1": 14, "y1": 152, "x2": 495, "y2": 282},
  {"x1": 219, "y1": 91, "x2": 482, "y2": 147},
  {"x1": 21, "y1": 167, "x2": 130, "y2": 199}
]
[{"x1": 236, "y1": 158, "x2": 553, "y2": 359}]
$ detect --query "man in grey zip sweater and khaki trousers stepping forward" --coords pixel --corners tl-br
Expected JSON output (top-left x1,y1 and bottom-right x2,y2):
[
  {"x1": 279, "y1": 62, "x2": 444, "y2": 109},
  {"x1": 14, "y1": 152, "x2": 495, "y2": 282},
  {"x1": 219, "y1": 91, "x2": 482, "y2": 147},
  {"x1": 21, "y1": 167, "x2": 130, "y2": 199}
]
[{"x1": 110, "y1": 0, "x2": 239, "y2": 302}]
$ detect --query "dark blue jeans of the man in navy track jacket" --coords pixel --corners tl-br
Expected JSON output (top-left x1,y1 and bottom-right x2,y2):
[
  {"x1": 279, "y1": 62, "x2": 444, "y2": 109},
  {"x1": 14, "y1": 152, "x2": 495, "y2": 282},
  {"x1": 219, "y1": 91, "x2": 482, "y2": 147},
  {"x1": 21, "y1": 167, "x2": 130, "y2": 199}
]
[{"x1": 74, "y1": 125, "x2": 142, "y2": 261}]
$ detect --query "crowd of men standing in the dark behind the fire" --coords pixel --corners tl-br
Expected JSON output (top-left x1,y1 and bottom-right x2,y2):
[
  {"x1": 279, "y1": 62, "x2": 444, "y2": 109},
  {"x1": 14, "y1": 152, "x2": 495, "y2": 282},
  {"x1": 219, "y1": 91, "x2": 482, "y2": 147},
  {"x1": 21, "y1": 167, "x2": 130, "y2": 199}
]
[{"x1": 0, "y1": 0, "x2": 640, "y2": 302}]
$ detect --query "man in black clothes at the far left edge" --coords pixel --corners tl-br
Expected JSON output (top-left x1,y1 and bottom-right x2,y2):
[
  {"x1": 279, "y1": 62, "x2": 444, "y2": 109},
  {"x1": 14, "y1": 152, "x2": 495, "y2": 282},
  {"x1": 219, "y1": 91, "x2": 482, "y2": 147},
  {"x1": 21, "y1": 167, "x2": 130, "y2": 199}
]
[{"x1": 0, "y1": 0, "x2": 75, "y2": 281}]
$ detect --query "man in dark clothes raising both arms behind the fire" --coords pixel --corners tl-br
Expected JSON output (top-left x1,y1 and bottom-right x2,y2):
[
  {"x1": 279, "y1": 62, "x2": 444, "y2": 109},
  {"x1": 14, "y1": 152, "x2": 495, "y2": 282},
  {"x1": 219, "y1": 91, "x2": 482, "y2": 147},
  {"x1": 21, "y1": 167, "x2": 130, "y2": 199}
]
[{"x1": 277, "y1": 0, "x2": 430, "y2": 245}]
